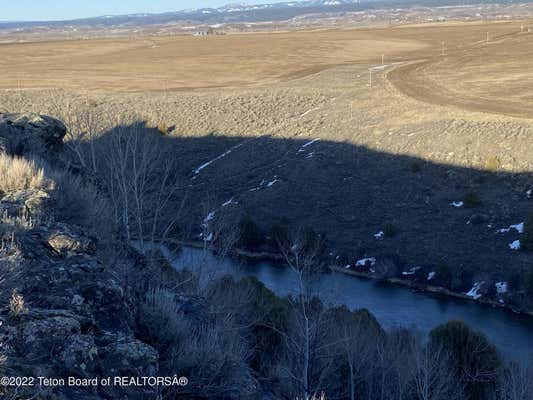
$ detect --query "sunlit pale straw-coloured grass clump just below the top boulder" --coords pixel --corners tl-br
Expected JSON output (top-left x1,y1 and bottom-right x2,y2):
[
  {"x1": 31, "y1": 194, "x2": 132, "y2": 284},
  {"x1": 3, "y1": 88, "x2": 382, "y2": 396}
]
[{"x1": 0, "y1": 154, "x2": 52, "y2": 193}]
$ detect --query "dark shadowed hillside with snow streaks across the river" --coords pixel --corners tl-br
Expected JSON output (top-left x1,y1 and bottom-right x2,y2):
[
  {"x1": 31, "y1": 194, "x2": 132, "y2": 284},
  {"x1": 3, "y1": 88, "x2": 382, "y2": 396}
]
[{"x1": 84, "y1": 120, "x2": 533, "y2": 290}]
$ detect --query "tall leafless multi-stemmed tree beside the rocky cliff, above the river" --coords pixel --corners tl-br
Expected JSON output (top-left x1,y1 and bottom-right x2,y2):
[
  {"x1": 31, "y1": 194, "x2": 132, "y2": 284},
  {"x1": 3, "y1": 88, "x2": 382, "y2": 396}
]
[{"x1": 98, "y1": 121, "x2": 186, "y2": 251}]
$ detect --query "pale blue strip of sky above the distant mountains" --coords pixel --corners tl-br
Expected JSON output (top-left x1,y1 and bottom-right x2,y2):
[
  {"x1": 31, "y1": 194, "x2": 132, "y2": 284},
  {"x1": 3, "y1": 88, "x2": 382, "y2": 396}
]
[{"x1": 0, "y1": 0, "x2": 290, "y2": 21}]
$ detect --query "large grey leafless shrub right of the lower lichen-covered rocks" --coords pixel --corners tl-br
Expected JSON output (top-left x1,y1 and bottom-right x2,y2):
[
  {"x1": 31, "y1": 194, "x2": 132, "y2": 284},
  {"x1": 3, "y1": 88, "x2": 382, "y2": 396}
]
[{"x1": 140, "y1": 288, "x2": 256, "y2": 399}]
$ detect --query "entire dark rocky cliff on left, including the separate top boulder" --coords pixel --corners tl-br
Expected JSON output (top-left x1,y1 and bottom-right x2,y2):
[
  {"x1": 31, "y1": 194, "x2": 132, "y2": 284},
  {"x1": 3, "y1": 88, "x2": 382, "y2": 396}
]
[{"x1": 0, "y1": 114, "x2": 159, "y2": 400}]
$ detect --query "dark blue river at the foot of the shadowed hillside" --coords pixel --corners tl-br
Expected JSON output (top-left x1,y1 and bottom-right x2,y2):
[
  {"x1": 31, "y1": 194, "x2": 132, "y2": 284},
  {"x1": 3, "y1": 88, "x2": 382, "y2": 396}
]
[{"x1": 144, "y1": 242, "x2": 533, "y2": 362}]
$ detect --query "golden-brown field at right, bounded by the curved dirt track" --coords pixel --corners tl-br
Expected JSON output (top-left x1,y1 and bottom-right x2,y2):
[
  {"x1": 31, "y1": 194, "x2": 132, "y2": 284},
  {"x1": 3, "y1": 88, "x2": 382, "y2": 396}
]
[{"x1": 389, "y1": 21, "x2": 533, "y2": 117}]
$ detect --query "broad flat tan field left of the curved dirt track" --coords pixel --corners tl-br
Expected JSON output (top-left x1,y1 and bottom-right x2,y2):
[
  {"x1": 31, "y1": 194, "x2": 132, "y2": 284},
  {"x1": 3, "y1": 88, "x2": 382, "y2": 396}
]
[{"x1": 0, "y1": 30, "x2": 425, "y2": 91}]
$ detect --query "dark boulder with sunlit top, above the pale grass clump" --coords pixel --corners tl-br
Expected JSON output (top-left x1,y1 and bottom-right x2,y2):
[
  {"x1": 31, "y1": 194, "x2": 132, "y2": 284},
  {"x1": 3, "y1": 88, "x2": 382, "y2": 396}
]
[{"x1": 0, "y1": 113, "x2": 67, "y2": 156}]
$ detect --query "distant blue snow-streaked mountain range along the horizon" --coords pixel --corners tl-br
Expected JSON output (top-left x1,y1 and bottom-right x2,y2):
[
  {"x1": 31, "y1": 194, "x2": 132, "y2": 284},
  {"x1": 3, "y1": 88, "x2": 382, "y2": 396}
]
[{"x1": 0, "y1": 0, "x2": 531, "y2": 28}]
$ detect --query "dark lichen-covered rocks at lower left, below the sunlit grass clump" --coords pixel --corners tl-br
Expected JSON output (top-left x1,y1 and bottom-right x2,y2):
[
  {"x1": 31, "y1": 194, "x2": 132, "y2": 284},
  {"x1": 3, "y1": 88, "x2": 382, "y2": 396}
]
[{"x1": 0, "y1": 189, "x2": 158, "y2": 399}]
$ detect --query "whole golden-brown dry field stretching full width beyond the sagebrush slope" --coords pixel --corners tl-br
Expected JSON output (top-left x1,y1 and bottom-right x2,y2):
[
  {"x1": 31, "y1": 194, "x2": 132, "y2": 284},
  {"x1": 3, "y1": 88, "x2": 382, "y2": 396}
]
[{"x1": 0, "y1": 21, "x2": 533, "y2": 117}]
